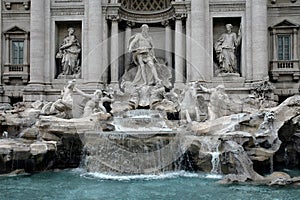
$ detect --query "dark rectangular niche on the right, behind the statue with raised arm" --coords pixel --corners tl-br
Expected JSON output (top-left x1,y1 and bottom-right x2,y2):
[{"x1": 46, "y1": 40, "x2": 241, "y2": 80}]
[{"x1": 212, "y1": 17, "x2": 243, "y2": 76}]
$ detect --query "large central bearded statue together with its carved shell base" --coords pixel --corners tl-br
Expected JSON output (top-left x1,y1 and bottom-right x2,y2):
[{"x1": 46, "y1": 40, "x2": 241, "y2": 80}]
[{"x1": 120, "y1": 24, "x2": 172, "y2": 109}]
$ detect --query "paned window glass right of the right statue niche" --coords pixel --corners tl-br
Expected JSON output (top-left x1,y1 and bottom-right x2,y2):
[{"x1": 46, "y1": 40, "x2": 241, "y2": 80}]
[{"x1": 278, "y1": 35, "x2": 291, "y2": 60}]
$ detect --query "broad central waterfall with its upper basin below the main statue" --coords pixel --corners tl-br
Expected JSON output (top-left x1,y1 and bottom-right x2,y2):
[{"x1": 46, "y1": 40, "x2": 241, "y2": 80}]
[{"x1": 79, "y1": 110, "x2": 188, "y2": 174}]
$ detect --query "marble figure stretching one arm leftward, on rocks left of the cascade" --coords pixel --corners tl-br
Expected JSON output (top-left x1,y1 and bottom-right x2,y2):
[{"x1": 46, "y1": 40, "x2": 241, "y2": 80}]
[{"x1": 75, "y1": 87, "x2": 107, "y2": 117}]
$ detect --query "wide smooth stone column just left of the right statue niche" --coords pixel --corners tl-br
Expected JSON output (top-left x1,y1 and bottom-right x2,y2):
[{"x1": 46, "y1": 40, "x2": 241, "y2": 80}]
[{"x1": 187, "y1": 0, "x2": 207, "y2": 81}]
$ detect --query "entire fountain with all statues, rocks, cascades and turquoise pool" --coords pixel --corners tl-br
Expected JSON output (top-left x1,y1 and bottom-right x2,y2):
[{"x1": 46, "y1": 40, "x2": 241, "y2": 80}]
[{"x1": 0, "y1": 24, "x2": 300, "y2": 199}]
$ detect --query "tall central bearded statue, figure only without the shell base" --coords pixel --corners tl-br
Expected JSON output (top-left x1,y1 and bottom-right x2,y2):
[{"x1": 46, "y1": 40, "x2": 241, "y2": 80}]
[{"x1": 128, "y1": 24, "x2": 162, "y2": 85}]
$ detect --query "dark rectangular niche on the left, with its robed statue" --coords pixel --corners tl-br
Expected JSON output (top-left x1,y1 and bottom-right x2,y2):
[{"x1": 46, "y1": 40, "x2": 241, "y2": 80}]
[{"x1": 54, "y1": 21, "x2": 82, "y2": 79}]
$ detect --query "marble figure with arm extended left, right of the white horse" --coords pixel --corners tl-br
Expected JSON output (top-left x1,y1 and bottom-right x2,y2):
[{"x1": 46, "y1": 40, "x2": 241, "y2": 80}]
[{"x1": 200, "y1": 85, "x2": 230, "y2": 120}]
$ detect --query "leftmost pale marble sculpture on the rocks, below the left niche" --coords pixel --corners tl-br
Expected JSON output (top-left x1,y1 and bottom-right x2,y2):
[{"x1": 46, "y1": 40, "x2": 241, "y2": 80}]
[{"x1": 48, "y1": 79, "x2": 76, "y2": 119}]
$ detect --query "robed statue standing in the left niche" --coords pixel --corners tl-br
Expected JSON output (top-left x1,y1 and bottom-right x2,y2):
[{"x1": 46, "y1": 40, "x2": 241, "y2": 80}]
[{"x1": 56, "y1": 27, "x2": 81, "y2": 78}]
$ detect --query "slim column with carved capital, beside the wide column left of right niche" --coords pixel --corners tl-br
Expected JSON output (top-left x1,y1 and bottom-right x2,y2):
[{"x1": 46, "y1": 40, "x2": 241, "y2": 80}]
[{"x1": 174, "y1": 15, "x2": 184, "y2": 83}]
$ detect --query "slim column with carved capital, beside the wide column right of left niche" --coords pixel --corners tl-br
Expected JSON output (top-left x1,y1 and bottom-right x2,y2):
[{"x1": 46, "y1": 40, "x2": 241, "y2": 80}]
[{"x1": 110, "y1": 16, "x2": 119, "y2": 84}]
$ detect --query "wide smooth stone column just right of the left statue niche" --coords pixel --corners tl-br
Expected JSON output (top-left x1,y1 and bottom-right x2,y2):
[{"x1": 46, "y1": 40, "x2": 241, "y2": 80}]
[{"x1": 87, "y1": 0, "x2": 105, "y2": 83}]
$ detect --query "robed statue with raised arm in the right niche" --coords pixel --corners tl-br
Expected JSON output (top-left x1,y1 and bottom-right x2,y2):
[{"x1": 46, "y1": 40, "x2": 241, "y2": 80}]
[{"x1": 214, "y1": 24, "x2": 242, "y2": 74}]
